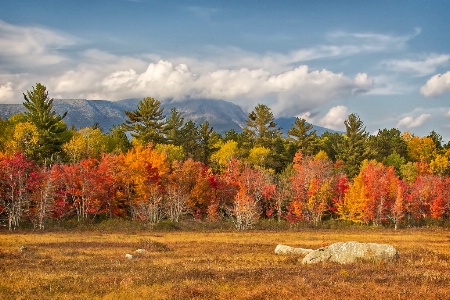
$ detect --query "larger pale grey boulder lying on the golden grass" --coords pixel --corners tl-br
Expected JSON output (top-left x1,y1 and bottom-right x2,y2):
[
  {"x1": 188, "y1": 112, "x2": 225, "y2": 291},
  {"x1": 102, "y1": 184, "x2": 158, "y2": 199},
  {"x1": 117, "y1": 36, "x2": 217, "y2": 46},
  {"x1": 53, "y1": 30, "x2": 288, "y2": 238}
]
[{"x1": 302, "y1": 242, "x2": 399, "y2": 264}]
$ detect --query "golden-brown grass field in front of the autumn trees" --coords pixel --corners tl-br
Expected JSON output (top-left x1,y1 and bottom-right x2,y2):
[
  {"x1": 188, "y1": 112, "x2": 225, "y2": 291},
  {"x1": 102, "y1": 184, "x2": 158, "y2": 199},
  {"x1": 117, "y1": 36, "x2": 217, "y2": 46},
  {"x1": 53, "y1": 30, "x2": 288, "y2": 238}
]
[{"x1": 0, "y1": 228, "x2": 450, "y2": 299}]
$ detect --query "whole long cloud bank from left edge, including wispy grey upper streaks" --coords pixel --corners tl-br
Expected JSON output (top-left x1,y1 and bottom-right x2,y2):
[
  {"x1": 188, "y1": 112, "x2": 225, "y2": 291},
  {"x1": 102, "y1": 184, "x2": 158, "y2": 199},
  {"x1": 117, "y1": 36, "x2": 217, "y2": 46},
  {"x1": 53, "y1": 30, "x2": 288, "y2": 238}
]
[{"x1": 0, "y1": 22, "x2": 373, "y2": 116}]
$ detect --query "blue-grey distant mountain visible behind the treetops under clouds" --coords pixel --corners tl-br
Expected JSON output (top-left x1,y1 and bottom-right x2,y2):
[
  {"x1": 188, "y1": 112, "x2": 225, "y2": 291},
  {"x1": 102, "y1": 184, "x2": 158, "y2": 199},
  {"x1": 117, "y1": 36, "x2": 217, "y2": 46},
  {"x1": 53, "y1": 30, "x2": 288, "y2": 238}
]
[{"x1": 0, "y1": 98, "x2": 338, "y2": 135}]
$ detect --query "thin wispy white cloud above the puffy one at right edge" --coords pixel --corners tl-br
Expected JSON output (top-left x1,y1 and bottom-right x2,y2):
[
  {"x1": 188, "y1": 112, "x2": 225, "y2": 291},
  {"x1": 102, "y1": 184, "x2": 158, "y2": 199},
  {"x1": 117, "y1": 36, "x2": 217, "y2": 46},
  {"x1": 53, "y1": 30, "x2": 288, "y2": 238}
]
[{"x1": 382, "y1": 54, "x2": 450, "y2": 76}]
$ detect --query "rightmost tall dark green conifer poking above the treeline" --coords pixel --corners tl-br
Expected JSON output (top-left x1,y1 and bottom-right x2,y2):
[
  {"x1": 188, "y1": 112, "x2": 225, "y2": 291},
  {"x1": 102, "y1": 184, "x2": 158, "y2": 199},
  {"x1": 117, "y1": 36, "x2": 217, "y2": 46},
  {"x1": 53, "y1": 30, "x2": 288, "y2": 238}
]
[{"x1": 336, "y1": 114, "x2": 370, "y2": 178}]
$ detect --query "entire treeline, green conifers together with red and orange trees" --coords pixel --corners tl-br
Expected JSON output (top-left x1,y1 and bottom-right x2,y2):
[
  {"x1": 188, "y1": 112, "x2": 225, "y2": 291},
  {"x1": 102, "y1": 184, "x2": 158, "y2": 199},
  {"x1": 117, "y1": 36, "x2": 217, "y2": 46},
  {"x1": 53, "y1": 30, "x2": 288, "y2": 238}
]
[{"x1": 0, "y1": 84, "x2": 450, "y2": 230}]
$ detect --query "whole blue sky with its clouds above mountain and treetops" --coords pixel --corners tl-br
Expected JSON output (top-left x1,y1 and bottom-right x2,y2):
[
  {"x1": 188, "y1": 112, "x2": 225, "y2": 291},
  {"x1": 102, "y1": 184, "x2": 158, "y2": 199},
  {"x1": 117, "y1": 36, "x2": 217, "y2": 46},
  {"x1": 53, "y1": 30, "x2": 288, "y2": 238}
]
[{"x1": 0, "y1": 0, "x2": 450, "y2": 141}]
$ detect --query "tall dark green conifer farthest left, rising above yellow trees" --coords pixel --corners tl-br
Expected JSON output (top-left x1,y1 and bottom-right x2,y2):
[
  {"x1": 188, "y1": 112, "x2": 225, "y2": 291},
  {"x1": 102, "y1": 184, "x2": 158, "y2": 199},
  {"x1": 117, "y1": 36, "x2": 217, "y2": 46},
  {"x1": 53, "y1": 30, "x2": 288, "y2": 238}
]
[{"x1": 23, "y1": 83, "x2": 70, "y2": 163}]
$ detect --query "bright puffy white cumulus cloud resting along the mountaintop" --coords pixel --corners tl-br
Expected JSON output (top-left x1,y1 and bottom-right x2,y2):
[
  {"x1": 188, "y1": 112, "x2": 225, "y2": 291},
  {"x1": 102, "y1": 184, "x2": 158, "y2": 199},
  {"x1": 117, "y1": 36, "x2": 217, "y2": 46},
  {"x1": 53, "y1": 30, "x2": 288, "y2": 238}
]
[{"x1": 96, "y1": 60, "x2": 372, "y2": 116}]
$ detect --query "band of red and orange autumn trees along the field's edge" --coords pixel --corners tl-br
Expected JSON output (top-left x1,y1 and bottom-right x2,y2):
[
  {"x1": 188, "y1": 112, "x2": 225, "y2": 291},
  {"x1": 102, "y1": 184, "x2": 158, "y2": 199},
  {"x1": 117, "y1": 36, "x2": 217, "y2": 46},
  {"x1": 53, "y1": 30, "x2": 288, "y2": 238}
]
[{"x1": 0, "y1": 144, "x2": 450, "y2": 230}]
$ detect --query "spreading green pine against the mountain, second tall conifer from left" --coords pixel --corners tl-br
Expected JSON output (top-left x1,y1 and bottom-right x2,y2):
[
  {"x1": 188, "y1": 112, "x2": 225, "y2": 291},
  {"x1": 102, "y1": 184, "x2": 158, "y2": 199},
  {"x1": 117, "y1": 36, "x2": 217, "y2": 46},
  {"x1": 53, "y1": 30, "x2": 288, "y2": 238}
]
[{"x1": 124, "y1": 97, "x2": 167, "y2": 145}]
